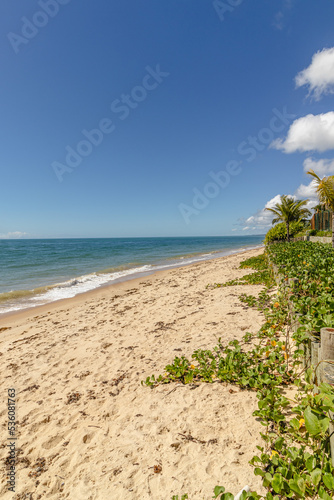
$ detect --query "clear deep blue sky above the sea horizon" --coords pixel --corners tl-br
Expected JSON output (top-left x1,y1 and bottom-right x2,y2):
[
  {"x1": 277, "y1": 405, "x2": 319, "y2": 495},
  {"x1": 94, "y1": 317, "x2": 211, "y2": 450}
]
[{"x1": 0, "y1": 0, "x2": 334, "y2": 238}]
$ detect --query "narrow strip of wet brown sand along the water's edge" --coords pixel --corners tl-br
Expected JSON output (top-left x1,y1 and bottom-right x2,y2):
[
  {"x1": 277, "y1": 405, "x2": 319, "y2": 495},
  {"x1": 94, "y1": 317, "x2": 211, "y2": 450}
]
[{"x1": 0, "y1": 245, "x2": 264, "y2": 325}]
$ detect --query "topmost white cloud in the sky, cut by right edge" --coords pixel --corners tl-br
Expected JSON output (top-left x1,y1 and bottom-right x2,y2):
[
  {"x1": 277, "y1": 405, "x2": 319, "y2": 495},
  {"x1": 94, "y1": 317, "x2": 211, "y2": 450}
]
[{"x1": 295, "y1": 47, "x2": 334, "y2": 100}]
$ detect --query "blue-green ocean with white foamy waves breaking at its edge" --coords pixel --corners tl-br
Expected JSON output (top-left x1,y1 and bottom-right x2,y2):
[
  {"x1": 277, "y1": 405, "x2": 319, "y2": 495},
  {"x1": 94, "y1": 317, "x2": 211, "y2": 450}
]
[{"x1": 0, "y1": 235, "x2": 264, "y2": 314}]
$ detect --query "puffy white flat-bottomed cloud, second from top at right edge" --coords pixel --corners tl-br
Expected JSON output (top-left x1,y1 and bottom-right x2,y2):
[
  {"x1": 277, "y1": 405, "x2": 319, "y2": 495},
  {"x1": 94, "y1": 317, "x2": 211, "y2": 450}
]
[{"x1": 270, "y1": 111, "x2": 334, "y2": 153}]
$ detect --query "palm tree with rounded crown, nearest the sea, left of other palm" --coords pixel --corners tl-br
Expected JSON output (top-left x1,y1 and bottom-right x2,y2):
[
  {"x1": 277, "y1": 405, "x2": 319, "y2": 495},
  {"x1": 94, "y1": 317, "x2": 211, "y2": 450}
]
[{"x1": 266, "y1": 194, "x2": 311, "y2": 241}]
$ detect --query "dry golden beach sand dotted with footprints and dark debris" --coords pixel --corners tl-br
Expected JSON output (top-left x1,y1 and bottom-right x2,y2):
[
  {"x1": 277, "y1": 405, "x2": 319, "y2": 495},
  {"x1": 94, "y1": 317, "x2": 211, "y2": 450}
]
[{"x1": 0, "y1": 250, "x2": 263, "y2": 500}]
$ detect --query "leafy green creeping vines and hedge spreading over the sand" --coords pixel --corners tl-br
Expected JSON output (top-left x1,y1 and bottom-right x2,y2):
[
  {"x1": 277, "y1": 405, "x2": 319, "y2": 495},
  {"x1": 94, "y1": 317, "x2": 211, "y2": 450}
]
[{"x1": 144, "y1": 247, "x2": 334, "y2": 500}]
